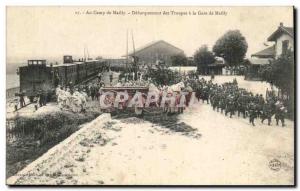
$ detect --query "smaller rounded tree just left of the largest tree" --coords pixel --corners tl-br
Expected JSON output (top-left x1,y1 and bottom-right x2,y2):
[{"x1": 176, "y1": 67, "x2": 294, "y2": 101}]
[{"x1": 194, "y1": 45, "x2": 215, "y2": 73}]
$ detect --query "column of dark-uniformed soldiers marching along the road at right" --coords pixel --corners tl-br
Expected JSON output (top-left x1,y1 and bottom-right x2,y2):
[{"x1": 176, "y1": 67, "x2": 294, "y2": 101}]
[{"x1": 187, "y1": 78, "x2": 287, "y2": 126}]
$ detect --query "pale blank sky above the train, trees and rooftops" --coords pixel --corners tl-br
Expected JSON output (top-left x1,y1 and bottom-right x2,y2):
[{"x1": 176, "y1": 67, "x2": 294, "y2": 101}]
[{"x1": 6, "y1": 6, "x2": 293, "y2": 63}]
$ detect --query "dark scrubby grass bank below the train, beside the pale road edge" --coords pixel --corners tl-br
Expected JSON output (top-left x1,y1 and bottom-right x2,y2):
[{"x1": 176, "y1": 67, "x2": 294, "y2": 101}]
[{"x1": 6, "y1": 112, "x2": 100, "y2": 177}]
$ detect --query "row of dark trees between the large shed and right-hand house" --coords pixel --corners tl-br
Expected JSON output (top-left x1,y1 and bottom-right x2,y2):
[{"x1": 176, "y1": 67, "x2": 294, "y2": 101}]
[{"x1": 171, "y1": 30, "x2": 248, "y2": 71}]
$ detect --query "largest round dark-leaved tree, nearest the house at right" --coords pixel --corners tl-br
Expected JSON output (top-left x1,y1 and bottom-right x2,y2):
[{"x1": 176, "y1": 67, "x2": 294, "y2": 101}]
[{"x1": 213, "y1": 30, "x2": 248, "y2": 67}]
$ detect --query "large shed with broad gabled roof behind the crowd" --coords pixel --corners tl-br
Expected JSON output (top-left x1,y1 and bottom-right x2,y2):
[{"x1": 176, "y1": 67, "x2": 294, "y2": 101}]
[{"x1": 128, "y1": 40, "x2": 184, "y2": 66}]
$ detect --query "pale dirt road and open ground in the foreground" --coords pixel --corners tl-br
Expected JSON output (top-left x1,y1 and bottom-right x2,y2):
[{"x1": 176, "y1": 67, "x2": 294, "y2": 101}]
[{"x1": 7, "y1": 103, "x2": 294, "y2": 185}]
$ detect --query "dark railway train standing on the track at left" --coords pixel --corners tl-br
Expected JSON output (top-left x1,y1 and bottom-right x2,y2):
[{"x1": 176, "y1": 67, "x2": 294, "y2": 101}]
[{"x1": 17, "y1": 55, "x2": 108, "y2": 102}]
